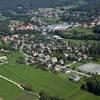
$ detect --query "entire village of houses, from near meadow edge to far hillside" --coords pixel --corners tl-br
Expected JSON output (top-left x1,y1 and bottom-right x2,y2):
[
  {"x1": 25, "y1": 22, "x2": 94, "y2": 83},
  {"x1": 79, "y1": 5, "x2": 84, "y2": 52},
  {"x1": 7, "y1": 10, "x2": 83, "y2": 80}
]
[{"x1": 0, "y1": 7, "x2": 100, "y2": 81}]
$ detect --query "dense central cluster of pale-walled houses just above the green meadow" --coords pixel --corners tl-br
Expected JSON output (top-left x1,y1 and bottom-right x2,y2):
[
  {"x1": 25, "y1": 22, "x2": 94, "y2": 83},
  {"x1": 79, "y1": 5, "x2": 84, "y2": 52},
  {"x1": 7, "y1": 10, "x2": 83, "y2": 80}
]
[{"x1": 2, "y1": 34, "x2": 91, "y2": 71}]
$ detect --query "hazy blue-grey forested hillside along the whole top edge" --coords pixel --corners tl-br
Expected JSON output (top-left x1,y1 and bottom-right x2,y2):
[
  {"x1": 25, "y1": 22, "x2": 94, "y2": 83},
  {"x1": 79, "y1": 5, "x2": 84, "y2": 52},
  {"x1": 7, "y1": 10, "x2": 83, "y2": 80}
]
[{"x1": 0, "y1": 0, "x2": 100, "y2": 9}]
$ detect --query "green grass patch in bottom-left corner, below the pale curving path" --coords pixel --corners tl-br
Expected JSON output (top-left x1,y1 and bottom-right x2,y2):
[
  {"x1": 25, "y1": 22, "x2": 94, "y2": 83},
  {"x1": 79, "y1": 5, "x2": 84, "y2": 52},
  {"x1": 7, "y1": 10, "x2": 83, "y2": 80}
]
[{"x1": 0, "y1": 79, "x2": 24, "y2": 100}]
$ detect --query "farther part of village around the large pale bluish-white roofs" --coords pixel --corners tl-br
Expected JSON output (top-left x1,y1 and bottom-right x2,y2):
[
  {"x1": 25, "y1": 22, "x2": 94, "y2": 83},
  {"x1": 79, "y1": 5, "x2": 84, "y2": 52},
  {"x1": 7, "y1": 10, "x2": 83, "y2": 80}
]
[{"x1": 6, "y1": 7, "x2": 100, "y2": 35}]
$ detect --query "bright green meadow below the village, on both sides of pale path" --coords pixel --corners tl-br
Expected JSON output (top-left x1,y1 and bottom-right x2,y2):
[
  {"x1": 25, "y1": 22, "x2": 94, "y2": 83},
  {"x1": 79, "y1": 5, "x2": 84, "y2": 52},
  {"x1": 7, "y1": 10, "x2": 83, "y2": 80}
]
[{"x1": 0, "y1": 54, "x2": 100, "y2": 100}]
